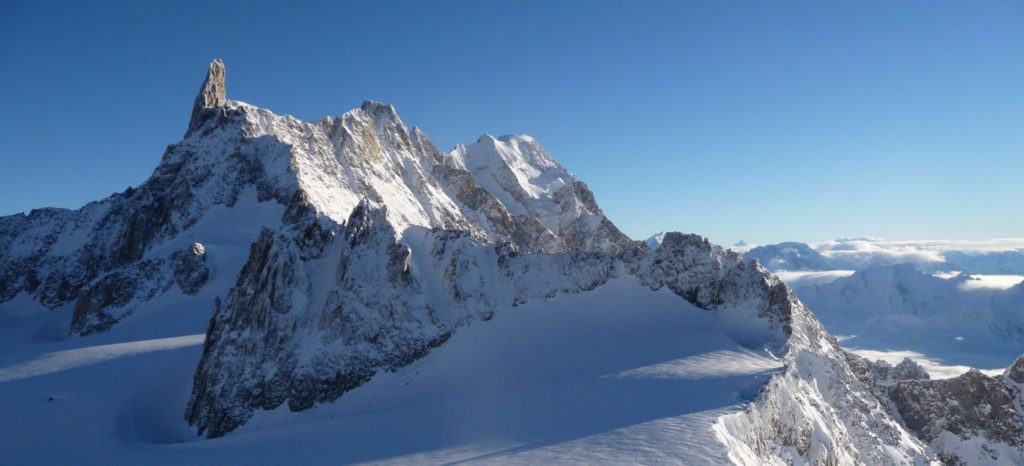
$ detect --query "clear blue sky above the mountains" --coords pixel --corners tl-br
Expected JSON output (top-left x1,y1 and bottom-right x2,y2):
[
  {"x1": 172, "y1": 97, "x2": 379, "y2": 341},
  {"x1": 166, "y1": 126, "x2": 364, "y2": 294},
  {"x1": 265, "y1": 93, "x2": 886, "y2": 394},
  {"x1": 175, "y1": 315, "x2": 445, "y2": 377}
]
[{"x1": 0, "y1": 0, "x2": 1024, "y2": 244}]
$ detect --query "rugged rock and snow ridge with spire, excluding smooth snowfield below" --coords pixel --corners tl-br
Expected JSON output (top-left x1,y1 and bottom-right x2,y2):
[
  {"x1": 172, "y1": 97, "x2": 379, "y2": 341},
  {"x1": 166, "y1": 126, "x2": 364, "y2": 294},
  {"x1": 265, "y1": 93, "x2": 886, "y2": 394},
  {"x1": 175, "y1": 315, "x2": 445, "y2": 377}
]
[{"x1": 0, "y1": 60, "x2": 1024, "y2": 464}]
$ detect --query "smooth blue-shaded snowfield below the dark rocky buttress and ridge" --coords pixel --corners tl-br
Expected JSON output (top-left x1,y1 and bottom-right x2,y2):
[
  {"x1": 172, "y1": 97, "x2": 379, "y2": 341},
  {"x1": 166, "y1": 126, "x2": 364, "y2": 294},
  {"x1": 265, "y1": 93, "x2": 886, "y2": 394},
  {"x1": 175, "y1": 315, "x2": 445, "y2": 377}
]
[{"x1": 0, "y1": 277, "x2": 781, "y2": 464}]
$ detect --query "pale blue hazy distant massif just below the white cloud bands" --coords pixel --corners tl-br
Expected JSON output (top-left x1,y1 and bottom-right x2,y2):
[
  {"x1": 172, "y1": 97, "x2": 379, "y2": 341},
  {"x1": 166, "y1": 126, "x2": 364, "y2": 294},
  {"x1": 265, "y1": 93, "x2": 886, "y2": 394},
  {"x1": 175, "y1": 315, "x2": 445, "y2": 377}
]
[{"x1": 795, "y1": 264, "x2": 1024, "y2": 368}]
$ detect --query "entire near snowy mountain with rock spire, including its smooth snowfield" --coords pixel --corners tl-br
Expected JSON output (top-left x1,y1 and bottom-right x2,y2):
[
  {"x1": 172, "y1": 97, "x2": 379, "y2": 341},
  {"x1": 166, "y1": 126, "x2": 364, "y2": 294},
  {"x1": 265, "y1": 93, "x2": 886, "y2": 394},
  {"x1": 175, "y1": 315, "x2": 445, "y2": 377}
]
[{"x1": 0, "y1": 61, "x2": 1021, "y2": 465}]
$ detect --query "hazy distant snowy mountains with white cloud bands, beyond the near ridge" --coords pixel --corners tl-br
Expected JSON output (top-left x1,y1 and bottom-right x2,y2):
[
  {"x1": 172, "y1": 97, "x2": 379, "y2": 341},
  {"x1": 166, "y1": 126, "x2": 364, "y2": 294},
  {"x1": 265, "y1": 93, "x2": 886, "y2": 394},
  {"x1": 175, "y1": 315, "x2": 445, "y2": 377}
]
[{"x1": 745, "y1": 239, "x2": 1024, "y2": 377}]
